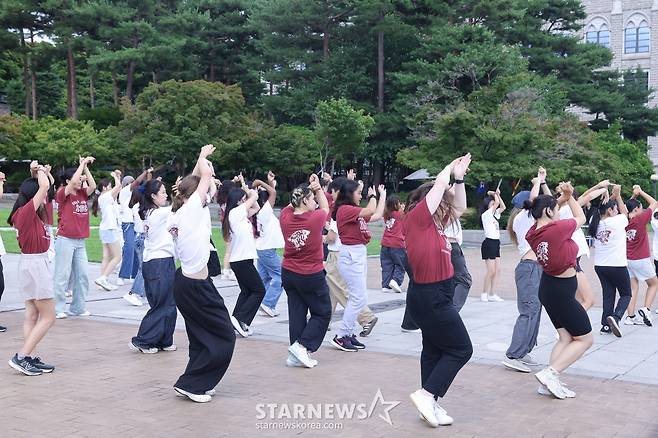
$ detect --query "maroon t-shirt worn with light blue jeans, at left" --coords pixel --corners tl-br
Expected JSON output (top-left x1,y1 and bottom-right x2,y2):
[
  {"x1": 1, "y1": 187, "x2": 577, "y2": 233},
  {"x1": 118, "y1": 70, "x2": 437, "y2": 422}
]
[{"x1": 55, "y1": 187, "x2": 89, "y2": 239}]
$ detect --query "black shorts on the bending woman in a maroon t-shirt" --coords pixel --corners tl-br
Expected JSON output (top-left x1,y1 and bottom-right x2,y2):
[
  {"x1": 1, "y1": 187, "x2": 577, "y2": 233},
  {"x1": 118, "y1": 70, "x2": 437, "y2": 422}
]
[{"x1": 539, "y1": 272, "x2": 592, "y2": 336}]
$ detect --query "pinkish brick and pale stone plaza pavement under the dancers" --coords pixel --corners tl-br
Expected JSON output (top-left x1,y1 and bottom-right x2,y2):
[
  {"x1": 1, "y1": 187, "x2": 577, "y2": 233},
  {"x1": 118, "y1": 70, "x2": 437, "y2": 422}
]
[{"x1": 0, "y1": 248, "x2": 658, "y2": 438}]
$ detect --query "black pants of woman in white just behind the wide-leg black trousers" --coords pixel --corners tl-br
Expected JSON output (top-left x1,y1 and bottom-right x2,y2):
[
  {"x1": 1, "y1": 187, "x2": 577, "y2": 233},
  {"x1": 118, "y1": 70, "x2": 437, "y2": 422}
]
[{"x1": 231, "y1": 259, "x2": 265, "y2": 325}]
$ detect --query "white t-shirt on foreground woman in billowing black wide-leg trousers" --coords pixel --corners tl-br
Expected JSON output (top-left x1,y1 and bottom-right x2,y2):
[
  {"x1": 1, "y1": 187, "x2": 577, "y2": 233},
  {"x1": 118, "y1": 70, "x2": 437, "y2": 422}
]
[{"x1": 168, "y1": 192, "x2": 212, "y2": 274}]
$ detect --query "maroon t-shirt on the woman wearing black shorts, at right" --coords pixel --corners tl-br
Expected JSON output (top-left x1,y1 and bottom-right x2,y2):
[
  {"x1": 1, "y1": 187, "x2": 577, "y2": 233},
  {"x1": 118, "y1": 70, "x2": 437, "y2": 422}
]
[{"x1": 525, "y1": 219, "x2": 578, "y2": 277}]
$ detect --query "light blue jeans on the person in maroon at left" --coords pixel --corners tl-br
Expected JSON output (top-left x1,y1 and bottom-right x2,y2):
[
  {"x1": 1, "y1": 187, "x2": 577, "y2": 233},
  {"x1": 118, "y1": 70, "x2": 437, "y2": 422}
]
[{"x1": 54, "y1": 236, "x2": 89, "y2": 315}]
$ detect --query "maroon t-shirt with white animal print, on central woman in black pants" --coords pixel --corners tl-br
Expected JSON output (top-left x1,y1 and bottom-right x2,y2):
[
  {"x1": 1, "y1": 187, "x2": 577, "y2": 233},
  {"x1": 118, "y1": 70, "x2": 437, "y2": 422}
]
[{"x1": 279, "y1": 205, "x2": 327, "y2": 275}]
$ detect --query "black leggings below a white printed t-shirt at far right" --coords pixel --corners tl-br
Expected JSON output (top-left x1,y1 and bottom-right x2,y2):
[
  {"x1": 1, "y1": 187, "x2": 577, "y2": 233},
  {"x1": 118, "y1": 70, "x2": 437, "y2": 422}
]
[{"x1": 594, "y1": 266, "x2": 631, "y2": 325}]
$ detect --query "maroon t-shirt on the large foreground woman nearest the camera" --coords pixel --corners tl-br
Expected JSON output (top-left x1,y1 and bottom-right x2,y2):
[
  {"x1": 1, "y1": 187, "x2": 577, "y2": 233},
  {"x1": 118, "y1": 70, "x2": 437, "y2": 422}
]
[{"x1": 400, "y1": 199, "x2": 455, "y2": 283}]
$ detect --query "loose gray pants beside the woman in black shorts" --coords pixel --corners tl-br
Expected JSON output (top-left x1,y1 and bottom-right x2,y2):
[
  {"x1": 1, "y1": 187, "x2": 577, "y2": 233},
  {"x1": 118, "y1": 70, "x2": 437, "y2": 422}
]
[{"x1": 507, "y1": 260, "x2": 542, "y2": 359}]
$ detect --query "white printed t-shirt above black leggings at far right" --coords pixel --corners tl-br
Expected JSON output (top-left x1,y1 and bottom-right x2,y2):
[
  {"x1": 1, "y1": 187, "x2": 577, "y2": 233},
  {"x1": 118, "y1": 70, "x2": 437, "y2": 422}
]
[{"x1": 594, "y1": 214, "x2": 628, "y2": 266}]
